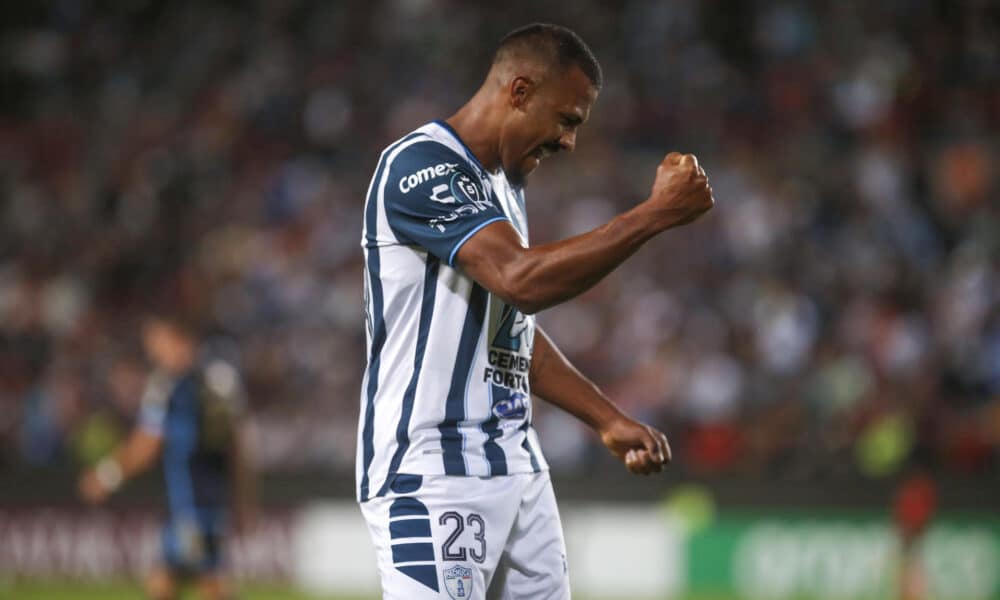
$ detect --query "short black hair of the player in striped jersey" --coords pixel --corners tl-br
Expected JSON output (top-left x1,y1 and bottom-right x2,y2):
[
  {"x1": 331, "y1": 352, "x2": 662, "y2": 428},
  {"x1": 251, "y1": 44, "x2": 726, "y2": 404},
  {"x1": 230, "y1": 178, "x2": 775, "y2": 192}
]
[{"x1": 493, "y1": 23, "x2": 604, "y2": 89}]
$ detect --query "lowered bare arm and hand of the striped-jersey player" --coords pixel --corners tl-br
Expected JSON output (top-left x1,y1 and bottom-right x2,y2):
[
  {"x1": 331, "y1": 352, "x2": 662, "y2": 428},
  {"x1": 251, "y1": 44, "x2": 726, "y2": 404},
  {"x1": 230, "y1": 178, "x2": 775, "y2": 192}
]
[{"x1": 530, "y1": 327, "x2": 670, "y2": 475}]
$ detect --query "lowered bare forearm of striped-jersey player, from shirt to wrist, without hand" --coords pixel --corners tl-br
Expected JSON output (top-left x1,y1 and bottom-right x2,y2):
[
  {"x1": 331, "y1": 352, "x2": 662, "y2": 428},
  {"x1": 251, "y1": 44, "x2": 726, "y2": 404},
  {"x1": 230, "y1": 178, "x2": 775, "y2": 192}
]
[{"x1": 530, "y1": 328, "x2": 624, "y2": 431}]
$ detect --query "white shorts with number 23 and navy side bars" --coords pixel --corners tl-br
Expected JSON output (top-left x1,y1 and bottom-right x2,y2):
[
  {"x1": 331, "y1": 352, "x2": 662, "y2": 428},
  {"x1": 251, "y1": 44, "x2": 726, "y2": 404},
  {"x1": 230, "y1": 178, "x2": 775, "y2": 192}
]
[{"x1": 361, "y1": 472, "x2": 570, "y2": 600}]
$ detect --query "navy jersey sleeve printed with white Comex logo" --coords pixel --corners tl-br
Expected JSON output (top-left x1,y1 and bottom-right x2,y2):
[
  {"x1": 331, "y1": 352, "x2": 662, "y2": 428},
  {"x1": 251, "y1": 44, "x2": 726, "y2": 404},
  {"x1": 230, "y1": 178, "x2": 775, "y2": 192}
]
[{"x1": 384, "y1": 142, "x2": 509, "y2": 266}]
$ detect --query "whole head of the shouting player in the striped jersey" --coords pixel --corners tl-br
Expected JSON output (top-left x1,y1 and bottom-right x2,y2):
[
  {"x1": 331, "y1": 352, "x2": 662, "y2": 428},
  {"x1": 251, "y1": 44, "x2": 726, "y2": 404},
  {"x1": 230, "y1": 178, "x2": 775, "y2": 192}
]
[{"x1": 487, "y1": 23, "x2": 602, "y2": 185}]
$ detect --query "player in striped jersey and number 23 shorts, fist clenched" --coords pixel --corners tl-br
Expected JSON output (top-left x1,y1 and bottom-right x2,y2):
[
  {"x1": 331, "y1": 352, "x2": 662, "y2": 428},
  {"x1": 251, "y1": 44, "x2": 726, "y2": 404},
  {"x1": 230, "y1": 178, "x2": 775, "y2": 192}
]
[{"x1": 357, "y1": 24, "x2": 713, "y2": 600}]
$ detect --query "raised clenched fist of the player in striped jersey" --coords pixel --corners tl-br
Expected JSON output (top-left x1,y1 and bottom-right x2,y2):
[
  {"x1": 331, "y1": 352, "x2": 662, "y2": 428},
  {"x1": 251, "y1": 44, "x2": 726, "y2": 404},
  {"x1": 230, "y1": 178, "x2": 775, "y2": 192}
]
[{"x1": 643, "y1": 152, "x2": 715, "y2": 229}]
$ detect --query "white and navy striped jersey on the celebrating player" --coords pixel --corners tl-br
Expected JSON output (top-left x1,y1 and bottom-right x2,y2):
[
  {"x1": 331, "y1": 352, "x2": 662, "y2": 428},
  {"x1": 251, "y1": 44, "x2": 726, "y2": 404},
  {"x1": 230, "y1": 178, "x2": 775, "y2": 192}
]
[{"x1": 357, "y1": 121, "x2": 548, "y2": 502}]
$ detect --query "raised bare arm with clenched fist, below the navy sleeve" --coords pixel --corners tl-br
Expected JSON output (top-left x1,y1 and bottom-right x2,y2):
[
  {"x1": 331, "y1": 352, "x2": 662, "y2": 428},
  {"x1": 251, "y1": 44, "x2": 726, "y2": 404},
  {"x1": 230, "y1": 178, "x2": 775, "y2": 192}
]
[{"x1": 456, "y1": 152, "x2": 715, "y2": 313}]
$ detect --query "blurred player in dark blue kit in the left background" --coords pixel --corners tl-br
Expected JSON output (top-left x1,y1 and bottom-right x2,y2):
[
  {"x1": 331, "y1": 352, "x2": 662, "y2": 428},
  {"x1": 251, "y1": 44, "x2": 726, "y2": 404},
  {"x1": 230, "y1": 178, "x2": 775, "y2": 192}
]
[{"x1": 80, "y1": 314, "x2": 252, "y2": 600}]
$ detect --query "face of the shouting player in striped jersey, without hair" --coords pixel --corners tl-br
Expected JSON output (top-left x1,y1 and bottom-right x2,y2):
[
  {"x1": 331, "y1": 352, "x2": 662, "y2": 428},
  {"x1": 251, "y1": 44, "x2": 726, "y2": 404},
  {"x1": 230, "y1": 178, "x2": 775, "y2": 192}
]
[{"x1": 500, "y1": 67, "x2": 597, "y2": 185}]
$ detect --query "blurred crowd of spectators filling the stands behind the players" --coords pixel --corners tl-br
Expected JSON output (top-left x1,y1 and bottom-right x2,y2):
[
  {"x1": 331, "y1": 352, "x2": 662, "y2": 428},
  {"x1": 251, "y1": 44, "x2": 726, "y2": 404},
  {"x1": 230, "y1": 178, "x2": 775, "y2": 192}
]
[{"x1": 0, "y1": 0, "x2": 1000, "y2": 478}]
